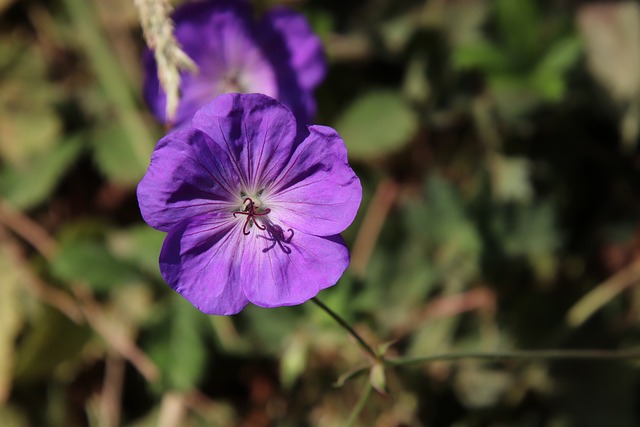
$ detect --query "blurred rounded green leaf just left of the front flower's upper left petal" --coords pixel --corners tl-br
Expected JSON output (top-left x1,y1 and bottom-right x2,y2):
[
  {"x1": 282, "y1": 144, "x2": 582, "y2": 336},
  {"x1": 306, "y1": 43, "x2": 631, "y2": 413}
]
[{"x1": 92, "y1": 125, "x2": 148, "y2": 187}]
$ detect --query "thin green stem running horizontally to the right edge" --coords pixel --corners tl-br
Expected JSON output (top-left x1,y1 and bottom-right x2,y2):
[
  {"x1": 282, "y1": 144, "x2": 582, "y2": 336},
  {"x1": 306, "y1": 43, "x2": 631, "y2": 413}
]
[{"x1": 385, "y1": 350, "x2": 640, "y2": 366}]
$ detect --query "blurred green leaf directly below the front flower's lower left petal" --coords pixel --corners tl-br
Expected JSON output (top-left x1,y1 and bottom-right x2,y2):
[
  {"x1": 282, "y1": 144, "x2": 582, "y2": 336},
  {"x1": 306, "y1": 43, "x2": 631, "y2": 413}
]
[{"x1": 145, "y1": 294, "x2": 210, "y2": 392}]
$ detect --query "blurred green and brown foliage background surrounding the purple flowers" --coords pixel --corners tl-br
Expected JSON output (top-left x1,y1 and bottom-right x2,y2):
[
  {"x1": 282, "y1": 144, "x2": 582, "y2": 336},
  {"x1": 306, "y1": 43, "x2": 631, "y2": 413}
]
[{"x1": 0, "y1": 0, "x2": 640, "y2": 427}]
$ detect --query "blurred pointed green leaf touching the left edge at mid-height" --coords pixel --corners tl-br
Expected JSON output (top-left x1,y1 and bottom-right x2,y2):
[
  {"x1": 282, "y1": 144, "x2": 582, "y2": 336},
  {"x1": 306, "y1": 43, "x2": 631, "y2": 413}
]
[{"x1": 0, "y1": 135, "x2": 83, "y2": 209}]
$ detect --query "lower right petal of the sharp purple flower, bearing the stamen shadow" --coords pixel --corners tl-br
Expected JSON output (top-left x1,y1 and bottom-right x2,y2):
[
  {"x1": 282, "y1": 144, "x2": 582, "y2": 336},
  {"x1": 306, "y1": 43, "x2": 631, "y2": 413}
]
[{"x1": 241, "y1": 231, "x2": 349, "y2": 307}]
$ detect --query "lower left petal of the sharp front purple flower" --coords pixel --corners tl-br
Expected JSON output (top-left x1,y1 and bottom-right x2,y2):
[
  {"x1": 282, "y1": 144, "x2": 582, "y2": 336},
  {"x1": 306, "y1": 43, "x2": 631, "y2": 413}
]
[{"x1": 160, "y1": 213, "x2": 248, "y2": 315}]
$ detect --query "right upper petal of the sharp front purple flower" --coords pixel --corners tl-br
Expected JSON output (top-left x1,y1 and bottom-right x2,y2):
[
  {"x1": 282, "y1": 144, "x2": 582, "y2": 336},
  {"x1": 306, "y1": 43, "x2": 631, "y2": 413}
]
[{"x1": 264, "y1": 126, "x2": 362, "y2": 236}]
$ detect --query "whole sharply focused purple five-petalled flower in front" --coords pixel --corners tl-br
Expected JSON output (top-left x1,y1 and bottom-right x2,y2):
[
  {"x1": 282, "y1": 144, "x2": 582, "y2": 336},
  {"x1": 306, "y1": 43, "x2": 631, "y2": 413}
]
[{"x1": 138, "y1": 94, "x2": 362, "y2": 315}]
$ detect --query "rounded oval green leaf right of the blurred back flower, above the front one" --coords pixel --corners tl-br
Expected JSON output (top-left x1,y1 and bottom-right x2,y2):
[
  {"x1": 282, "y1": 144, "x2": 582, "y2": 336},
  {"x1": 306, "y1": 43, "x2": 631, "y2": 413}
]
[{"x1": 336, "y1": 90, "x2": 418, "y2": 158}]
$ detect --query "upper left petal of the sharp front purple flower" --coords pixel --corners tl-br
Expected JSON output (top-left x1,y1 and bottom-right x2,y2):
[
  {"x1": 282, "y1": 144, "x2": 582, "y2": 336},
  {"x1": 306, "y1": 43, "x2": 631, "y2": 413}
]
[{"x1": 137, "y1": 130, "x2": 242, "y2": 231}]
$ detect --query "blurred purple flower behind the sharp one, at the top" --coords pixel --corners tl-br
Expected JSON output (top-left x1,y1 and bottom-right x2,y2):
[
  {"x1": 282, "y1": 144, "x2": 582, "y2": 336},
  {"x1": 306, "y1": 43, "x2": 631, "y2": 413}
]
[{"x1": 144, "y1": 0, "x2": 326, "y2": 126}]
